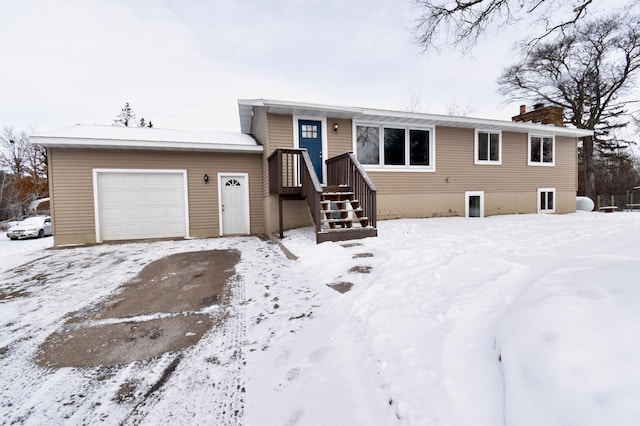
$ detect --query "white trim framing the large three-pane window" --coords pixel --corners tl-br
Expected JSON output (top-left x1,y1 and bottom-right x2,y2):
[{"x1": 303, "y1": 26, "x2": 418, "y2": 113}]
[{"x1": 351, "y1": 121, "x2": 436, "y2": 173}]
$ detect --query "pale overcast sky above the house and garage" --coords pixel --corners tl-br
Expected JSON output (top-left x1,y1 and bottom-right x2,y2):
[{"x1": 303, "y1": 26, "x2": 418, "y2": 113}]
[{"x1": 0, "y1": 0, "x2": 592, "y2": 131}]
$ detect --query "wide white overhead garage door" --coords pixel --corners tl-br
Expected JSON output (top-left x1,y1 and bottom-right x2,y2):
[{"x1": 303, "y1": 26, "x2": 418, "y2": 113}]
[{"x1": 96, "y1": 171, "x2": 187, "y2": 241}]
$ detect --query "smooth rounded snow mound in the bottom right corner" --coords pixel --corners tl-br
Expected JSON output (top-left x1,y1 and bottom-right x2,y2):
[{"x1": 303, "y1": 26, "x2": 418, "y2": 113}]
[{"x1": 498, "y1": 232, "x2": 640, "y2": 425}]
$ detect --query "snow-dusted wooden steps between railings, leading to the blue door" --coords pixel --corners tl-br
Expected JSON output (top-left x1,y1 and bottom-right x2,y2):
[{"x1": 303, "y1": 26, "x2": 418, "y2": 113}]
[{"x1": 317, "y1": 186, "x2": 378, "y2": 242}]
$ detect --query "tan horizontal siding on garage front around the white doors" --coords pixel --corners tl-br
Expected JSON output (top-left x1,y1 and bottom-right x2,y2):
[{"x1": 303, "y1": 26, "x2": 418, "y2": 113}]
[{"x1": 49, "y1": 148, "x2": 264, "y2": 245}]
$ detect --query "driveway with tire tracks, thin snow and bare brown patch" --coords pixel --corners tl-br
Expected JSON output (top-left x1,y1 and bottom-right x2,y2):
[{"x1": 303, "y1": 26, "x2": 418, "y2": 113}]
[{"x1": 0, "y1": 237, "x2": 332, "y2": 426}]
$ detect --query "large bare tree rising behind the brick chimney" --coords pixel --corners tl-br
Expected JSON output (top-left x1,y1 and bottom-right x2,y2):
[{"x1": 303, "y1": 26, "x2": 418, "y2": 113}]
[{"x1": 498, "y1": 15, "x2": 640, "y2": 197}]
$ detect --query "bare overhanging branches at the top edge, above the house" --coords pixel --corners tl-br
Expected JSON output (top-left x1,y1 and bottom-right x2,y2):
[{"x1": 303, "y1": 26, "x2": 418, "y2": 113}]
[{"x1": 414, "y1": 0, "x2": 639, "y2": 50}]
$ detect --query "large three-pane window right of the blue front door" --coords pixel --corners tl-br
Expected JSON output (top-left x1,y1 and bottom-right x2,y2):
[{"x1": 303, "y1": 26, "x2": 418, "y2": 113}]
[{"x1": 355, "y1": 124, "x2": 435, "y2": 171}]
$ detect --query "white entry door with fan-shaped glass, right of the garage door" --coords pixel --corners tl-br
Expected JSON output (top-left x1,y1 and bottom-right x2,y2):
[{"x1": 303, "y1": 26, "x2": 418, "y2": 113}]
[{"x1": 218, "y1": 174, "x2": 249, "y2": 235}]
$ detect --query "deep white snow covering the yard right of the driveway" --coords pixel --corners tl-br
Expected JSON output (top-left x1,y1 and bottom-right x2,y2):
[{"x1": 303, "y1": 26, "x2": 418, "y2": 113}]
[{"x1": 246, "y1": 213, "x2": 640, "y2": 425}]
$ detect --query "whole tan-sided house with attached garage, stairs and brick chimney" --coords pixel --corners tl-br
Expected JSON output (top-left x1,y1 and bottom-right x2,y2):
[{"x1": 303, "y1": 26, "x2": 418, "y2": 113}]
[{"x1": 32, "y1": 99, "x2": 592, "y2": 245}]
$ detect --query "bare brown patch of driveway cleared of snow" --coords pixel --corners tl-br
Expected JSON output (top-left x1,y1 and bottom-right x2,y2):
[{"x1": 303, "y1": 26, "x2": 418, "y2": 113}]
[{"x1": 36, "y1": 250, "x2": 240, "y2": 368}]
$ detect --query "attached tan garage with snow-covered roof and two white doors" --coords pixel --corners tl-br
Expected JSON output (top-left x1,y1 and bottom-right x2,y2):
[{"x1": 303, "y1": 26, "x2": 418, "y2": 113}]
[{"x1": 31, "y1": 124, "x2": 265, "y2": 247}]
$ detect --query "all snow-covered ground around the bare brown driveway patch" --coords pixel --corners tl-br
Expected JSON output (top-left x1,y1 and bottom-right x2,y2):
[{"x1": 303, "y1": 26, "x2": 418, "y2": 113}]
[{"x1": 0, "y1": 213, "x2": 640, "y2": 425}]
